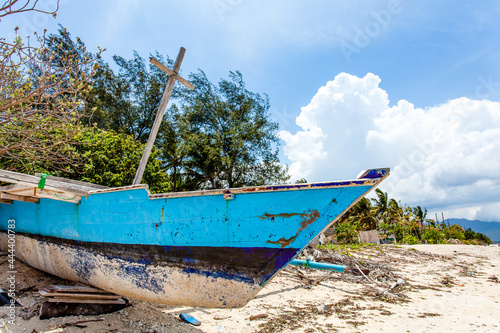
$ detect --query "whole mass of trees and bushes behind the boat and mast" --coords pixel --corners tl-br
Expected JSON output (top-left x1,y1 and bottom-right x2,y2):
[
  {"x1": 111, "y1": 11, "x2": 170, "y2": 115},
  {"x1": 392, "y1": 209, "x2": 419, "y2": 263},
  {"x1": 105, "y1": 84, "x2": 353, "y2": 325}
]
[{"x1": 0, "y1": 22, "x2": 289, "y2": 191}]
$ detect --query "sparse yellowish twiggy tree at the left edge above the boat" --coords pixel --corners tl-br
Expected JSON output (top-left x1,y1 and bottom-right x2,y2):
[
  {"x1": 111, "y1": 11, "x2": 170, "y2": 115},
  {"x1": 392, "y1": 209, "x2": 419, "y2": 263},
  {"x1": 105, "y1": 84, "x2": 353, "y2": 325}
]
[{"x1": 0, "y1": 26, "x2": 101, "y2": 171}]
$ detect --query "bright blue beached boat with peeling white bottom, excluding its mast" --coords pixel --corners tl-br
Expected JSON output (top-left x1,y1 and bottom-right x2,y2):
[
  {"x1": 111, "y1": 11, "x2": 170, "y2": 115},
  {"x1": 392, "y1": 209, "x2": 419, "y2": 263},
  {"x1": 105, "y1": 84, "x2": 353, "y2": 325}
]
[{"x1": 0, "y1": 169, "x2": 389, "y2": 307}]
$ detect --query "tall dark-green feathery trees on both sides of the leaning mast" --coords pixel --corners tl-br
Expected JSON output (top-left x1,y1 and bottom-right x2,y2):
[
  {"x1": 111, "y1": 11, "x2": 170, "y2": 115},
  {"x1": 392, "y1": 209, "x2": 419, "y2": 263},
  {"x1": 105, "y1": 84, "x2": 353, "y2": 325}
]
[{"x1": 87, "y1": 52, "x2": 288, "y2": 191}]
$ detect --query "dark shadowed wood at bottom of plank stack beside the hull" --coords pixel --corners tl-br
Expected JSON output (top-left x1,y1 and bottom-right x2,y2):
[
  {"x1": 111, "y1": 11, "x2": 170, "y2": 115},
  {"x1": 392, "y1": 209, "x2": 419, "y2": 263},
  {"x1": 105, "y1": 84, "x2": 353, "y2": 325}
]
[{"x1": 40, "y1": 302, "x2": 128, "y2": 319}]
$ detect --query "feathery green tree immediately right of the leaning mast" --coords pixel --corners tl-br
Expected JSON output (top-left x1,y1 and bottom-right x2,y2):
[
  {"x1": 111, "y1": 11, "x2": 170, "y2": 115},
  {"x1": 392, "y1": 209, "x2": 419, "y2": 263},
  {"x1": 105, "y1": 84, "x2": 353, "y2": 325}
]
[{"x1": 178, "y1": 71, "x2": 289, "y2": 189}]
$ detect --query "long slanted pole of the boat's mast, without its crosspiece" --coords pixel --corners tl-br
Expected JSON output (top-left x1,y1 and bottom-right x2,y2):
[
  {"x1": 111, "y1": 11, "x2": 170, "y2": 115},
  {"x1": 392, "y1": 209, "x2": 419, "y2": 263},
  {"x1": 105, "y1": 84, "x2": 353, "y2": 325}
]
[{"x1": 132, "y1": 47, "x2": 194, "y2": 185}]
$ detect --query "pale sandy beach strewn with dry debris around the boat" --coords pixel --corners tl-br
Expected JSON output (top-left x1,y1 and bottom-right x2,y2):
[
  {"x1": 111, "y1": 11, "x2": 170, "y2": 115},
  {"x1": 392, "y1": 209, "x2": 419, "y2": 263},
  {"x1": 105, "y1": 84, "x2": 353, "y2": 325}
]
[{"x1": 0, "y1": 245, "x2": 500, "y2": 333}]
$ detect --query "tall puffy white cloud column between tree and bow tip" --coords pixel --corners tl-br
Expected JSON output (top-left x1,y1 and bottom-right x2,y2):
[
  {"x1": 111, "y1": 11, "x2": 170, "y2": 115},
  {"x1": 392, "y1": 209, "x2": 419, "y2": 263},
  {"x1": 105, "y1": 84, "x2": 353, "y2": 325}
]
[{"x1": 279, "y1": 73, "x2": 389, "y2": 180}]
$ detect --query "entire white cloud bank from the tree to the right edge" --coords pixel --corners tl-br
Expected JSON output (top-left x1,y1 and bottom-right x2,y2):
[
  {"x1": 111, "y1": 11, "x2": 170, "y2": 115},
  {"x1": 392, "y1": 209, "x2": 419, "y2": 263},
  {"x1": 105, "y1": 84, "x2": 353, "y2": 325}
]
[{"x1": 279, "y1": 73, "x2": 500, "y2": 220}]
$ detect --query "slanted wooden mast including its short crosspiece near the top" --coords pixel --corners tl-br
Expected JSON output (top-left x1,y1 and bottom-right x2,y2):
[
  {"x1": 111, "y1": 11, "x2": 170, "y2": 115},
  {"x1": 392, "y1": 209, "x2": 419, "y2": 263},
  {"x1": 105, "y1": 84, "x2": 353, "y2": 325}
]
[{"x1": 132, "y1": 47, "x2": 194, "y2": 185}]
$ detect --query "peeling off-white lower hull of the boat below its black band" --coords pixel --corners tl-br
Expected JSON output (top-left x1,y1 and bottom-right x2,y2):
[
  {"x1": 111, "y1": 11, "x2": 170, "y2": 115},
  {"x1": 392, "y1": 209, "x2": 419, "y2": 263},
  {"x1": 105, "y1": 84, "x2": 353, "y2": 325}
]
[{"x1": 0, "y1": 233, "x2": 290, "y2": 308}]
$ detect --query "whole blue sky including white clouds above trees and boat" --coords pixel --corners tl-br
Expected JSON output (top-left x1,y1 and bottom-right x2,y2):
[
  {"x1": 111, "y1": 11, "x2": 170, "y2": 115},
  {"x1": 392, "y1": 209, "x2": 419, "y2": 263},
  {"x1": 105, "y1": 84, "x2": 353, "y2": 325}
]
[{"x1": 0, "y1": 0, "x2": 500, "y2": 220}]
